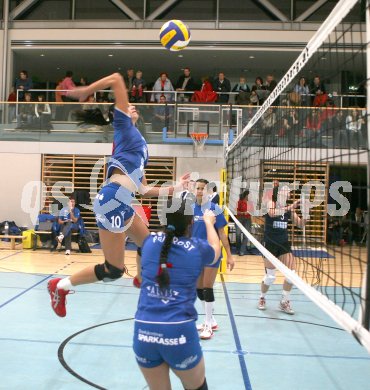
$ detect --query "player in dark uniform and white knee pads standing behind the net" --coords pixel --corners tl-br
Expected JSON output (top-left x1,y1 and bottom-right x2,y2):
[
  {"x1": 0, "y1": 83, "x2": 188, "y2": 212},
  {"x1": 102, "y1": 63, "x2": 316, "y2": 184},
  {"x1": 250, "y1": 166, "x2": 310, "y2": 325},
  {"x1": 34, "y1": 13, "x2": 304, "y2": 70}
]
[{"x1": 258, "y1": 186, "x2": 307, "y2": 315}]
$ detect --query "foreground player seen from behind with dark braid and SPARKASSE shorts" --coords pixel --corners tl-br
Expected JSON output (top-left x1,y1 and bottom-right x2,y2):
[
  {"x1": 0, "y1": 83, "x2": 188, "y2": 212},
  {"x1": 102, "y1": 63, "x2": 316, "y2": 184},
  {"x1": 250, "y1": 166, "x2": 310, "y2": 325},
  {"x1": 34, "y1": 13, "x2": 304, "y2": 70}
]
[{"x1": 133, "y1": 198, "x2": 220, "y2": 390}]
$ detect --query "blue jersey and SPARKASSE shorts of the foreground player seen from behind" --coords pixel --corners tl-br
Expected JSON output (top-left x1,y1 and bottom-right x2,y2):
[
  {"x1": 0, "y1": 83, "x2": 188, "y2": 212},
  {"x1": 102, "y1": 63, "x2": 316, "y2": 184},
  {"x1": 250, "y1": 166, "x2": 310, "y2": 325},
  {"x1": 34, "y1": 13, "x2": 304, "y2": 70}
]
[{"x1": 133, "y1": 233, "x2": 215, "y2": 370}]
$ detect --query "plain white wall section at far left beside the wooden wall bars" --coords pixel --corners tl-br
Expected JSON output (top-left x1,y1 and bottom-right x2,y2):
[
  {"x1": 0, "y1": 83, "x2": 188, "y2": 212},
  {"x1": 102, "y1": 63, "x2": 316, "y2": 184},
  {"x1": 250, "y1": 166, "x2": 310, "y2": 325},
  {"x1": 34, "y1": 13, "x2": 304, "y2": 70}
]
[{"x1": 0, "y1": 153, "x2": 41, "y2": 227}]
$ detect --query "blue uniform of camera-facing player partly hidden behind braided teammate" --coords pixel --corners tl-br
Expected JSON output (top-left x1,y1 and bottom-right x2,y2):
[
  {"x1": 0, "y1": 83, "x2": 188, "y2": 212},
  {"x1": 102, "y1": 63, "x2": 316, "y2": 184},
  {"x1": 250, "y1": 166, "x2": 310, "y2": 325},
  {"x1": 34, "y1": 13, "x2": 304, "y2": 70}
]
[{"x1": 191, "y1": 202, "x2": 227, "y2": 268}]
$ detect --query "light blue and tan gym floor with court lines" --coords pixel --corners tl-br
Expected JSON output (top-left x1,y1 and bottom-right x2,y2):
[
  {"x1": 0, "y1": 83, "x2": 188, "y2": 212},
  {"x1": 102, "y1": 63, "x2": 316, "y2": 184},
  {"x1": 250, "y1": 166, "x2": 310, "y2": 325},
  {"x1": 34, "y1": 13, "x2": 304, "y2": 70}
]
[{"x1": 0, "y1": 249, "x2": 370, "y2": 390}]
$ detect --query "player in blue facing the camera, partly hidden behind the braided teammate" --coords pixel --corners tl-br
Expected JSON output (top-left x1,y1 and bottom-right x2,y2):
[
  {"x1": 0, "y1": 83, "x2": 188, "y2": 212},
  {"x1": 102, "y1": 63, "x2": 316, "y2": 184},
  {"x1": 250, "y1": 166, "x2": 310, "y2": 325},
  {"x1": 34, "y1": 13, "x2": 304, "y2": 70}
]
[{"x1": 192, "y1": 179, "x2": 234, "y2": 340}]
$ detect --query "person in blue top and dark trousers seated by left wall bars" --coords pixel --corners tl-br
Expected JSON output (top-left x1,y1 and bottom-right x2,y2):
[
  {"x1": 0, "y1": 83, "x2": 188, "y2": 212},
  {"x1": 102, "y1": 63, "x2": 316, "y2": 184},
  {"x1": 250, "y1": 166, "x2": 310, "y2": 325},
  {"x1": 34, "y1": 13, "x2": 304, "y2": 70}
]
[{"x1": 56, "y1": 196, "x2": 80, "y2": 255}]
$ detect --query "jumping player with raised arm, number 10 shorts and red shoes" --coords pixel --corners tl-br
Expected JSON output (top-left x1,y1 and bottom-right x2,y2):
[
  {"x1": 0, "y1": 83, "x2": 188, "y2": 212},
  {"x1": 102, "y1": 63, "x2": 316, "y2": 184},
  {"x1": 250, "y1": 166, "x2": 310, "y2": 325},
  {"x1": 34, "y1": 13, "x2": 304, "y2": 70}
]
[{"x1": 48, "y1": 73, "x2": 189, "y2": 317}]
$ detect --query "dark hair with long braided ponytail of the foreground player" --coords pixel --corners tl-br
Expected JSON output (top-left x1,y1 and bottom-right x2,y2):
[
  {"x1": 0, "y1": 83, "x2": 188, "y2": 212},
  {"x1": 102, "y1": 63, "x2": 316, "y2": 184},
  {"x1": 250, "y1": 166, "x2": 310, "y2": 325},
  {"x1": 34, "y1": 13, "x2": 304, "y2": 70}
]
[{"x1": 156, "y1": 199, "x2": 193, "y2": 289}]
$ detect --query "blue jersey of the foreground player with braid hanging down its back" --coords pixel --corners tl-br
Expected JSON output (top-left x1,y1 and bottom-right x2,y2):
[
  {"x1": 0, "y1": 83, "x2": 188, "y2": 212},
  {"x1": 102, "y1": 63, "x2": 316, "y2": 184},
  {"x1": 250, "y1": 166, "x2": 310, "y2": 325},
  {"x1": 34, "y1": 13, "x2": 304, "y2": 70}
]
[{"x1": 135, "y1": 233, "x2": 215, "y2": 323}]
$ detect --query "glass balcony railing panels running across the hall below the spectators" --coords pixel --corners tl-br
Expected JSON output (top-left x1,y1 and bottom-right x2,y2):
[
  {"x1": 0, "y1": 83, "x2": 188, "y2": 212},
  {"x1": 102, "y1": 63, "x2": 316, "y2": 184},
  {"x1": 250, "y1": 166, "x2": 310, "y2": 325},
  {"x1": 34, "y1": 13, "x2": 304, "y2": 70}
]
[{"x1": 0, "y1": 102, "x2": 367, "y2": 148}]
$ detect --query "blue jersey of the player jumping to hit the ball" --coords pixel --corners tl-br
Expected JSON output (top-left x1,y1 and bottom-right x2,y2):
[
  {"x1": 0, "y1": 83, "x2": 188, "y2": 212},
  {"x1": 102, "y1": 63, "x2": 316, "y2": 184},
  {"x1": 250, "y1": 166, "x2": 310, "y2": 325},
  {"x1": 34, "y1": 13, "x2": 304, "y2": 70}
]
[{"x1": 107, "y1": 108, "x2": 148, "y2": 187}]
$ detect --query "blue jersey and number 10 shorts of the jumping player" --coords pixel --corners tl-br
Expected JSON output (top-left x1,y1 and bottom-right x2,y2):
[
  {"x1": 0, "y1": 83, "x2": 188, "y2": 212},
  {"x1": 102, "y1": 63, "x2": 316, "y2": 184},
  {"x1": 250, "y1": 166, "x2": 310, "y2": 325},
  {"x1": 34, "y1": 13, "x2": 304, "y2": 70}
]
[{"x1": 94, "y1": 108, "x2": 148, "y2": 232}]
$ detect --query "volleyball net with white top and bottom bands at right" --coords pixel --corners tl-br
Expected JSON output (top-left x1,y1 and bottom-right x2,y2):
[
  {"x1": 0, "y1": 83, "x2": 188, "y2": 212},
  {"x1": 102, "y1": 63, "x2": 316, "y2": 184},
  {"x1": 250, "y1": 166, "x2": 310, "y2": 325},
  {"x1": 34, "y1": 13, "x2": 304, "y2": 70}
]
[{"x1": 225, "y1": 0, "x2": 370, "y2": 352}]
